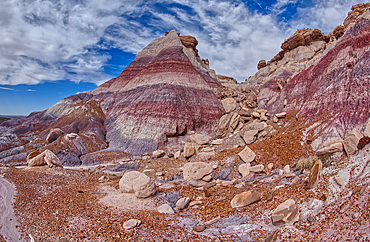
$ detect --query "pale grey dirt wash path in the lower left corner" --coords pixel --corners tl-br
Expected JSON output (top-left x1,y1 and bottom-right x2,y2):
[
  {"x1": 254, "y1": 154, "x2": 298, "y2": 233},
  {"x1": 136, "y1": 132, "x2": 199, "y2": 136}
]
[{"x1": 0, "y1": 177, "x2": 22, "y2": 242}]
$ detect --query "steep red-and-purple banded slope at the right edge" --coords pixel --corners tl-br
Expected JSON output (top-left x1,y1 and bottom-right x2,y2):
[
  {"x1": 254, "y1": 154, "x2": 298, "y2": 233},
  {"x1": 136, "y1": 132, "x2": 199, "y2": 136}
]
[{"x1": 261, "y1": 12, "x2": 370, "y2": 149}]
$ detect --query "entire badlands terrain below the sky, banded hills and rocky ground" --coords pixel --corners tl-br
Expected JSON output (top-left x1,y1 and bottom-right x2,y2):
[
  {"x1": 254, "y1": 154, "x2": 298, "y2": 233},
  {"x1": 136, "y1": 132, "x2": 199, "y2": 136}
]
[{"x1": 0, "y1": 3, "x2": 370, "y2": 241}]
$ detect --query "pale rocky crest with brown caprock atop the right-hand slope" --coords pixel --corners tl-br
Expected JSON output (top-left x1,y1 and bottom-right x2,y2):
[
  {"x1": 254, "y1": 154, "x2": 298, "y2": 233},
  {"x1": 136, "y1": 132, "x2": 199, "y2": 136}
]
[{"x1": 241, "y1": 4, "x2": 370, "y2": 97}]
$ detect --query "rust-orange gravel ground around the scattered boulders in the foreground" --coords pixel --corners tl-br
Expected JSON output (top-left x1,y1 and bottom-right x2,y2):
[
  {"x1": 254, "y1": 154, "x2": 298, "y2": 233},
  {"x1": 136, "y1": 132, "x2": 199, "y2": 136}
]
[{"x1": 0, "y1": 129, "x2": 370, "y2": 242}]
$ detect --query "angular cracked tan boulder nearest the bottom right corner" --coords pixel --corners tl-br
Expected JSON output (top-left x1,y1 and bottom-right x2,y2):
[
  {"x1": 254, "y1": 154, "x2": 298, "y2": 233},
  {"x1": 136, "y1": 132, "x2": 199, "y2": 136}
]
[{"x1": 271, "y1": 199, "x2": 299, "y2": 225}]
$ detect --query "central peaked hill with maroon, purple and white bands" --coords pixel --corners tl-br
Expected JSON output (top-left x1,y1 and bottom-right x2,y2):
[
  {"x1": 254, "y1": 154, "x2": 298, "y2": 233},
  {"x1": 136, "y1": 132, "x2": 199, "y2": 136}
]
[{"x1": 91, "y1": 31, "x2": 224, "y2": 154}]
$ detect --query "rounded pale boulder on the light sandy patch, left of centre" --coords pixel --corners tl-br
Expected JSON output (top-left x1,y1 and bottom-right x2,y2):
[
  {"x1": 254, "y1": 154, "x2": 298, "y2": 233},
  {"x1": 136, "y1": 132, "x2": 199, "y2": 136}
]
[{"x1": 119, "y1": 171, "x2": 157, "y2": 198}]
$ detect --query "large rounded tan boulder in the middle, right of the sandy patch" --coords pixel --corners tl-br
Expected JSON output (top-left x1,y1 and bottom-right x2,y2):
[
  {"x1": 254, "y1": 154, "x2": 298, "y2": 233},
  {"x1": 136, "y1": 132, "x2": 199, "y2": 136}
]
[{"x1": 183, "y1": 162, "x2": 213, "y2": 187}]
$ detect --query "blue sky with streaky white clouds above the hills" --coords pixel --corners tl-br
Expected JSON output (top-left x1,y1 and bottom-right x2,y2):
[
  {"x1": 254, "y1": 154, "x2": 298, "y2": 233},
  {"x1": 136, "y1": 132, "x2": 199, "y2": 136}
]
[{"x1": 0, "y1": 0, "x2": 361, "y2": 115}]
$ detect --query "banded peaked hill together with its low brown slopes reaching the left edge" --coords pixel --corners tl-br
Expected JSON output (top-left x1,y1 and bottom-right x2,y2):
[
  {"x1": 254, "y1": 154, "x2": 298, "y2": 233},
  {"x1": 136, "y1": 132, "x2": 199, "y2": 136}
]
[{"x1": 0, "y1": 31, "x2": 224, "y2": 159}]
